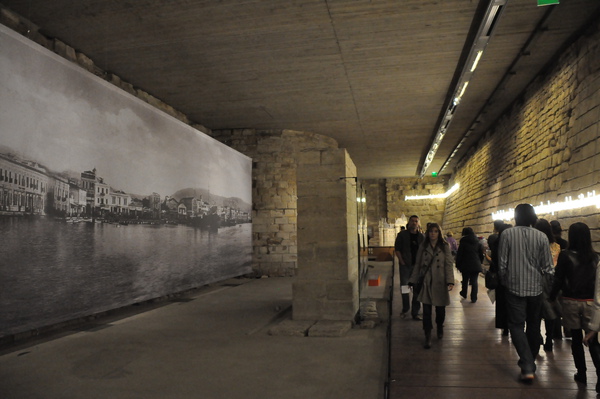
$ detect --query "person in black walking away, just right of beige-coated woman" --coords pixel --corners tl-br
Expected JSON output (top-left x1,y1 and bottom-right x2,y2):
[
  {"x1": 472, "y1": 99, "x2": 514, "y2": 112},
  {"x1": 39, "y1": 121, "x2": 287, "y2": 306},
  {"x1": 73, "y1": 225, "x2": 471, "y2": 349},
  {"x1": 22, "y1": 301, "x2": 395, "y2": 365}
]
[{"x1": 456, "y1": 227, "x2": 483, "y2": 303}]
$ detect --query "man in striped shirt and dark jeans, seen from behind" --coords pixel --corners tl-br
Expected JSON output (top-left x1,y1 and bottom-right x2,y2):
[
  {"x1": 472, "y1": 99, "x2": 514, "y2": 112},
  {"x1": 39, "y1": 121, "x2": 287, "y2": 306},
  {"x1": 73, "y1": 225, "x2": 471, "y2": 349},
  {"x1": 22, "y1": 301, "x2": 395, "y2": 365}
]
[{"x1": 498, "y1": 204, "x2": 554, "y2": 382}]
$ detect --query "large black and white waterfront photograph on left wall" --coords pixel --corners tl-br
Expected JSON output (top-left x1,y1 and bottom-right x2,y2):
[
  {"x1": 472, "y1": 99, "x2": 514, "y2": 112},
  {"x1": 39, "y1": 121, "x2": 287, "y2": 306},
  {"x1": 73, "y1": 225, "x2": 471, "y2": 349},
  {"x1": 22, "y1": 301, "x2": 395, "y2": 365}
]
[{"x1": 0, "y1": 26, "x2": 252, "y2": 337}]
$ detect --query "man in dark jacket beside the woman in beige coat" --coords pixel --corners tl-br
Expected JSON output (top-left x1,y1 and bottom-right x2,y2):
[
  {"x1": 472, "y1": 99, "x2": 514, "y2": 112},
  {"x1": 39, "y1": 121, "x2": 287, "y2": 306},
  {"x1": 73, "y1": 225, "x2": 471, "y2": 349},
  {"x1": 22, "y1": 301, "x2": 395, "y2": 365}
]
[{"x1": 394, "y1": 215, "x2": 425, "y2": 320}]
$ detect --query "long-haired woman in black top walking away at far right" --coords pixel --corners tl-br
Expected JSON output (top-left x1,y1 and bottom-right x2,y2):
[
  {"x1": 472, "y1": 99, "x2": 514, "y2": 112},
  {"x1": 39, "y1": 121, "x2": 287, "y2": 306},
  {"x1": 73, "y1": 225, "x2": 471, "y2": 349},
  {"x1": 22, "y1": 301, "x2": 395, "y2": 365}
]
[{"x1": 550, "y1": 222, "x2": 600, "y2": 393}]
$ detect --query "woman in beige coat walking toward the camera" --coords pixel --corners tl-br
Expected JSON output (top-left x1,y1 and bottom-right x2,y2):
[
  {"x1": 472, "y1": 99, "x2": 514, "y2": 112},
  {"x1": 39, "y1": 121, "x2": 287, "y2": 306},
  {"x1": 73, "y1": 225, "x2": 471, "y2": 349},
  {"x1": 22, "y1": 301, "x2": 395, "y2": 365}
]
[{"x1": 409, "y1": 223, "x2": 454, "y2": 349}]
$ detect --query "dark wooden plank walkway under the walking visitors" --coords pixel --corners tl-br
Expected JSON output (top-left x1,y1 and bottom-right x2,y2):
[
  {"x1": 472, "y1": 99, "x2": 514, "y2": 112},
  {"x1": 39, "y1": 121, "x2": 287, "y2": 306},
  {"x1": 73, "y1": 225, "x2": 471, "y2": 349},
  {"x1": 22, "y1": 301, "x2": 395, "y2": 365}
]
[{"x1": 389, "y1": 273, "x2": 596, "y2": 399}]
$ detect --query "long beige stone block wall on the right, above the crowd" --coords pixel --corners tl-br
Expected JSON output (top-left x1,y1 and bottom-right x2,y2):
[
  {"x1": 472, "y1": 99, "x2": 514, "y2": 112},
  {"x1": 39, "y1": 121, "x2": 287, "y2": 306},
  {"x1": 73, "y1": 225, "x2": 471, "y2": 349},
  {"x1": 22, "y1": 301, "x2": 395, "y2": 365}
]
[{"x1": 444, "y1": 22, "x2": 600, "y2": 248}]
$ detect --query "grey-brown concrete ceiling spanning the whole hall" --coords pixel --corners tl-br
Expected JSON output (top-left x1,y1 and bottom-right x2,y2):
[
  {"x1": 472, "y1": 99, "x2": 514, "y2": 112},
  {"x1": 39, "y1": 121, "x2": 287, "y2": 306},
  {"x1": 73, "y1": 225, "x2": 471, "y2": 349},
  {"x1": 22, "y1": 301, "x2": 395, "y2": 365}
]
[{"x1": 0, "y1": 0, "x2": 600, "y2": 178}]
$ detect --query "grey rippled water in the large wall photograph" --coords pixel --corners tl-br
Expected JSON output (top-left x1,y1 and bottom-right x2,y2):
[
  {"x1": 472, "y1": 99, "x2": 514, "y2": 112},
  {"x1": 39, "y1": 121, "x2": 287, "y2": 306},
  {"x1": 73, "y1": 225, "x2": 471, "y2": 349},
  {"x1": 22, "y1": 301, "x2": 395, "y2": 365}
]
[{"x1": 0, "y1": 217, "x2": 252, "y2": 336}]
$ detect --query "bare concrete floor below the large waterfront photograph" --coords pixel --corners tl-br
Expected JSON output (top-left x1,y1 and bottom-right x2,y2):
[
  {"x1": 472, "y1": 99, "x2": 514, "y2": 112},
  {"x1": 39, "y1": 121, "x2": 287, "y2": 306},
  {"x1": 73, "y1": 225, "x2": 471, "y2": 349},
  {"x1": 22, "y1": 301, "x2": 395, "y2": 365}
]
[{"x1": 0, "y1": 278, "x2": 387, "y2": 399}]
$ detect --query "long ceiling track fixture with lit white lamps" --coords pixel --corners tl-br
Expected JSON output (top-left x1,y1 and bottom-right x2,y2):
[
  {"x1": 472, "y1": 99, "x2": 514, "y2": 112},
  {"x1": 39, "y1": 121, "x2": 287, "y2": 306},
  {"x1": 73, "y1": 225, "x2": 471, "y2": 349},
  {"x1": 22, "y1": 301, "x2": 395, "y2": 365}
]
[{"x1": 419, "y1": 0, "x2": 508, "y2": 178}]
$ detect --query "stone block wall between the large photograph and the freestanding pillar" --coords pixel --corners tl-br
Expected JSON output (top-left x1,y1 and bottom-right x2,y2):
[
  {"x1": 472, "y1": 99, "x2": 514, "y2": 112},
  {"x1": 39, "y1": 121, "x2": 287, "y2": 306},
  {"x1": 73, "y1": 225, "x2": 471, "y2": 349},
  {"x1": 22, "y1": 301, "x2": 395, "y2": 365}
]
[{"x1": 209, "y1": 129, "x2": 338, "y2": 276}]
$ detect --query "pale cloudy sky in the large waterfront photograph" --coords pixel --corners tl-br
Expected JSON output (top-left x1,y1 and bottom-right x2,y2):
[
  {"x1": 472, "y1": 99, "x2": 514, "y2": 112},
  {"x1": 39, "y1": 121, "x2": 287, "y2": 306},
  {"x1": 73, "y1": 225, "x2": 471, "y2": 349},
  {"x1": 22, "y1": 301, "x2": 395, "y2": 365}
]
[{"x1": 0, "y1": 25, "x2": 251, "y2": 203}]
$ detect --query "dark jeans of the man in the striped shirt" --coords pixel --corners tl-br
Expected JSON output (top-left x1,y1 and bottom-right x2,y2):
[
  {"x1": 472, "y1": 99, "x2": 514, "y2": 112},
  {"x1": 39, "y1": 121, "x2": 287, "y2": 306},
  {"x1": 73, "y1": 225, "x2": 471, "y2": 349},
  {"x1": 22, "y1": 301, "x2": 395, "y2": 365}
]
[{"x1": 506, "y1": 291, "x2": 542, "y2": 373}]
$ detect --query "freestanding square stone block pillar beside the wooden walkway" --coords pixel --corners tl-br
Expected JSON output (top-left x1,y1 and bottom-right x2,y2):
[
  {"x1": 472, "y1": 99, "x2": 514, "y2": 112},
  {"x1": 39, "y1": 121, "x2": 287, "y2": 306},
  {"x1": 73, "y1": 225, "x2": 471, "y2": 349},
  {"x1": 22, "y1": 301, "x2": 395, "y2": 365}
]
[{"x1": 292, "y1": 149, "x2": 359, "y2": 321}]
